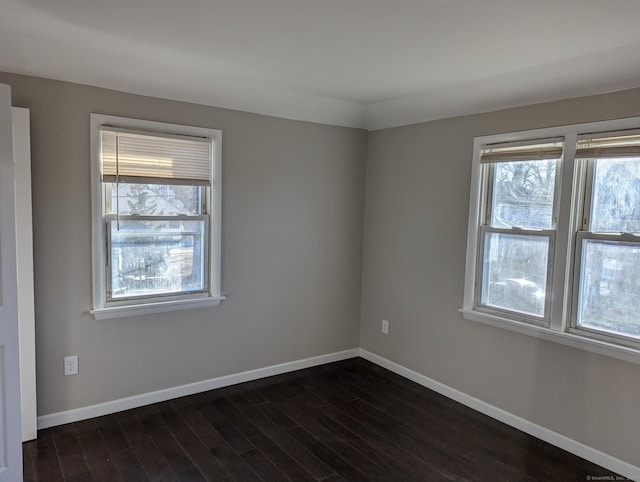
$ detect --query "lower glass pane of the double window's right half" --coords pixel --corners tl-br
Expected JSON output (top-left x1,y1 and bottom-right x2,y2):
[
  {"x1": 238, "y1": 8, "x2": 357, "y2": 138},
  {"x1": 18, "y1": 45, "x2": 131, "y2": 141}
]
[{"x1": 577, "y1": 239, "x2": 640, "y2": 339}]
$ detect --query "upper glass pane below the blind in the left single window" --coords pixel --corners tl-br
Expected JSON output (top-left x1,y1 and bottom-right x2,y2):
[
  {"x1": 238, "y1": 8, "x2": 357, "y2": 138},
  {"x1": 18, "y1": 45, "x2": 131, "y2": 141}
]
[{"x1": 107, "y1": 183, "x2": 202, "y2": 216}]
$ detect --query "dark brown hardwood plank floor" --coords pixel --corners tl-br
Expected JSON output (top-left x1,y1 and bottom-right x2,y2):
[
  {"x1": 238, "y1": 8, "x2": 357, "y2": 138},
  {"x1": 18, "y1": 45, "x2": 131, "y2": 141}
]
[{"x1": 23, "y1": 358, "x2": 621, "y2": 482}]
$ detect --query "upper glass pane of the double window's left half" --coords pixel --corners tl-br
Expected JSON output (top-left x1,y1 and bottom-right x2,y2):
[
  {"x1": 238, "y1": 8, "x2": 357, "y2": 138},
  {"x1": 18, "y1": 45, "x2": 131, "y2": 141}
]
[{"x1": 491, "y1": 160, "x2": 558, "y2": 229}]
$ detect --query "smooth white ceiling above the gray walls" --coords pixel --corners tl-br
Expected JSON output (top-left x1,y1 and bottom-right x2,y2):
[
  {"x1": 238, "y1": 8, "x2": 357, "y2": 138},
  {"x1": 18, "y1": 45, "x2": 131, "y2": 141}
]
[{"x1": 0, "y1": 0, "x2": 640, "y2": 129}]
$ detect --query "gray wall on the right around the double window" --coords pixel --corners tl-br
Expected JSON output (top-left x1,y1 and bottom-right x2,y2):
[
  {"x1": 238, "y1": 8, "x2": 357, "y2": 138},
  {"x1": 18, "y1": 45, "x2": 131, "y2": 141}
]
[{"x1": 360, "y1": 90, "x2": 640, "y2": 466}]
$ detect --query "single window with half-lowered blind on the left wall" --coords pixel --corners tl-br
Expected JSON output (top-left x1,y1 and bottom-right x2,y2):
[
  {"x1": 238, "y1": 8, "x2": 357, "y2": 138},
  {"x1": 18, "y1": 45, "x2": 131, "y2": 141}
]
[{"x1": 91, "y1": 114, "x2": 222, "y2": 318}]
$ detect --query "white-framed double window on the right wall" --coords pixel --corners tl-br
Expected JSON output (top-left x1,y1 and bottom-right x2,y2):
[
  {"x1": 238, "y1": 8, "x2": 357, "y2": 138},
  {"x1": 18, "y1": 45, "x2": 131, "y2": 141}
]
[{"x1": 461, "y1": 119, "x2": 640, "y2": 363}]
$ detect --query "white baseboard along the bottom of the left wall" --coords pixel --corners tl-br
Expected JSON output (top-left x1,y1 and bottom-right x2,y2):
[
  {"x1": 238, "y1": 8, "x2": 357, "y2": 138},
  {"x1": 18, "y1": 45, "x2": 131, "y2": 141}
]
[{"x1": 38, "y1": 348, "x2": 360, "y2": 429}]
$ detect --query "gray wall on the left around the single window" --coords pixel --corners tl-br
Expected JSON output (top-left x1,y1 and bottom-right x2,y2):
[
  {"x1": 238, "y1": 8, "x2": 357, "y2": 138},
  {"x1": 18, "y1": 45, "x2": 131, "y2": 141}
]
[{"x1": 0, "y1": 74, "x2": 367, "y2": 415}]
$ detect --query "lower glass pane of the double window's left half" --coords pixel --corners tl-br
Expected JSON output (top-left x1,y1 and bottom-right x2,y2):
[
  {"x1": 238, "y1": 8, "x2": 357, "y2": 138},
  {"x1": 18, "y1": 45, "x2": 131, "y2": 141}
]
[{"x1": 481, "y1": 233, "x2": 549, "y2": 317}]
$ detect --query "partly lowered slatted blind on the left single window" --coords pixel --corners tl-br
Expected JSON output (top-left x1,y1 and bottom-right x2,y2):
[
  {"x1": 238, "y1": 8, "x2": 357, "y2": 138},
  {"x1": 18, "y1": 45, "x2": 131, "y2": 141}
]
[{"x1": 100, "y1": 126, "x2": 212, "y2": 186}]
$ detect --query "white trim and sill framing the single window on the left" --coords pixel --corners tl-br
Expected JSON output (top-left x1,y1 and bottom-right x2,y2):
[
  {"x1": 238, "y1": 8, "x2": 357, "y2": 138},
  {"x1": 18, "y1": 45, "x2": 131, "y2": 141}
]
[{"x1": 89, "y1": 113, "x2": 225, "y2": 320}]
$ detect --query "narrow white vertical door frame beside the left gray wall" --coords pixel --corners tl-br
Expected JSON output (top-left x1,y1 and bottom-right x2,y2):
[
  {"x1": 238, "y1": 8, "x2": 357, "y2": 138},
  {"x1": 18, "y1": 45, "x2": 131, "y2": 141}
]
[{"x1": 11, "y1": 107, "x2": 37, "y2": 442}]
